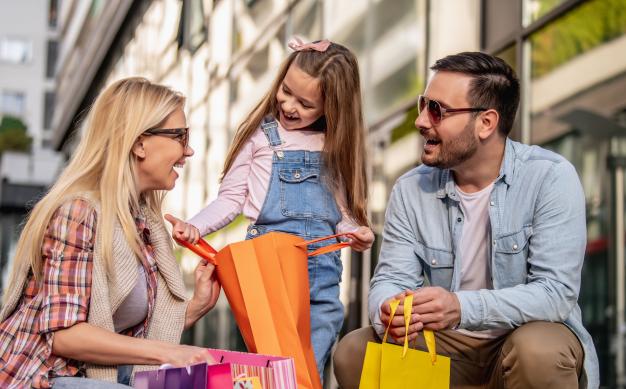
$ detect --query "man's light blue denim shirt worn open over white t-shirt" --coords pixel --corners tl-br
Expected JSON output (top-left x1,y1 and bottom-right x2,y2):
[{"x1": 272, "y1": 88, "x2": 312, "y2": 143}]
[{"x1": 369, "y1": 139, "x2": 599, "y2": 388}]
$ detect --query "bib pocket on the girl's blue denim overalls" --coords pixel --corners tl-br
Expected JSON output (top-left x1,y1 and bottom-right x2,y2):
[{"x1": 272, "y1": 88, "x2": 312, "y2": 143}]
[{"x1": 278, "y1": 168, "x2": 331, "y2": 219}]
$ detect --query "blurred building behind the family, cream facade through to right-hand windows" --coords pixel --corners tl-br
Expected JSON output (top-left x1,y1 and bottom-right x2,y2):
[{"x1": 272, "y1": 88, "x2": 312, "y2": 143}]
[{"x1": 47, "y1": 0, "x2": 626, "y2": 385}]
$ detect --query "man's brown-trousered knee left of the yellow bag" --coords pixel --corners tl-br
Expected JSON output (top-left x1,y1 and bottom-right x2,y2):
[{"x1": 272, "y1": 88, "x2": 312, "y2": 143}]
[{"x1": 333, "y1": 327, "x2": 379, "y2": 389}]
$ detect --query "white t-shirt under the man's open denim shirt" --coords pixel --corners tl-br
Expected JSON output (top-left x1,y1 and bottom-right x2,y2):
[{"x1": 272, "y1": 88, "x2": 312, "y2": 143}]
[{"x1": 456, "y1": 183, "x2": 508, "y2": 339}]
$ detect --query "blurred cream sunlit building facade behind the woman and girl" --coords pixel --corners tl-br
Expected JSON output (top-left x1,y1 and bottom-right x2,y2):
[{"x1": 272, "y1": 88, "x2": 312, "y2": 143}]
[{"x1": 95, "y1": 0, "x2": 480, "y2": 384}]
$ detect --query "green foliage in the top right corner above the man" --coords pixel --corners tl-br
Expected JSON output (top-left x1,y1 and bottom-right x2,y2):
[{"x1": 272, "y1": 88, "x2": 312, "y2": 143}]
[{"x1": 530, "y1": 0, "x2": 626, "y2": 78}]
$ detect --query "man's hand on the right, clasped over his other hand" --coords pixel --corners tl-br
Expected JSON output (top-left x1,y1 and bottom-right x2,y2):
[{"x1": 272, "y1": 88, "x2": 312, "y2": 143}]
[{"x1": 413, "y1": 286, "x2": 461, "y2": 330}]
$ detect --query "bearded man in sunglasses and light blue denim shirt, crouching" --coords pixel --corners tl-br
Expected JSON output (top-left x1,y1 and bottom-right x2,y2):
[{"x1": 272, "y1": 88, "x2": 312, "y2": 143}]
[{"x1": 334, "y1": 52, "x2": 599, "y2": 389}]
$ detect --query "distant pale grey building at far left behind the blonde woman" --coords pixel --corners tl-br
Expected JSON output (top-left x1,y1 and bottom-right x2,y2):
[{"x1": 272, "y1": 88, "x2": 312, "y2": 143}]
[{"x1": 0, "y1": 0, "x2": 63, "y2": 290}]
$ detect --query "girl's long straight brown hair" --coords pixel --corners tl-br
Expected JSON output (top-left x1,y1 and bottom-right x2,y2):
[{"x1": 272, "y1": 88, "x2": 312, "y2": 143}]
[{"x1": 222, "y1": 43, "x2": 369, "y2": 226}]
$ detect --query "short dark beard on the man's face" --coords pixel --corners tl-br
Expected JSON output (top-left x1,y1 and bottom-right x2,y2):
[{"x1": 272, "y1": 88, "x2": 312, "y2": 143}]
[{"x1": 422, "y1": 120, "x2": 478, "y2": 169}]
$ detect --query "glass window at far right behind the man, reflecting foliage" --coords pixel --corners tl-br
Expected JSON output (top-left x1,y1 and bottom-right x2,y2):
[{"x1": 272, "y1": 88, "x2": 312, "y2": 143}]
[{"x1": 526, "y1": 0, "x2": 626, "y2": 378}]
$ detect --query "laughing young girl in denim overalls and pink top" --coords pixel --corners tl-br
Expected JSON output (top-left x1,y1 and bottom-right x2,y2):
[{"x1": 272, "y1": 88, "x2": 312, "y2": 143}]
[{"x1": 166, "y1": 39, "x2": 374, "y2": 376}]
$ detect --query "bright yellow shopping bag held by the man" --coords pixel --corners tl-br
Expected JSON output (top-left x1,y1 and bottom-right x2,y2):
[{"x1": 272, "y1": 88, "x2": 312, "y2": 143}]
[{"x1": 359, "y1": 295, "x2": 450, "y2": 389}]
